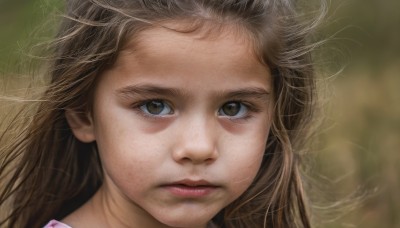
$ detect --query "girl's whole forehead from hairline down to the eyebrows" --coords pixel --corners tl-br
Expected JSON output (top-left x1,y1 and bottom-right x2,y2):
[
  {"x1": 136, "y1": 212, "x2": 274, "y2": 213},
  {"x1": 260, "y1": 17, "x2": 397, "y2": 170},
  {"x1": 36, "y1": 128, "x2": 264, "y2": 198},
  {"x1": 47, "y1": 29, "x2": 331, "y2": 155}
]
[{"x1": 100, "y1": 20, "x2": 272, "y2": 91}]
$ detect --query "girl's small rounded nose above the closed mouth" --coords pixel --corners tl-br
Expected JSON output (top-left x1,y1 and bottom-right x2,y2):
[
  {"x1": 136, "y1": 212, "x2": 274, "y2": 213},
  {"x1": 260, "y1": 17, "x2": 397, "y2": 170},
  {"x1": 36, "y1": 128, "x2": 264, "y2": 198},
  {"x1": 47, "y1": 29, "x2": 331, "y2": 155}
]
[{"x1": 172, "y1": 118, "x2": 219, "y2": 164}]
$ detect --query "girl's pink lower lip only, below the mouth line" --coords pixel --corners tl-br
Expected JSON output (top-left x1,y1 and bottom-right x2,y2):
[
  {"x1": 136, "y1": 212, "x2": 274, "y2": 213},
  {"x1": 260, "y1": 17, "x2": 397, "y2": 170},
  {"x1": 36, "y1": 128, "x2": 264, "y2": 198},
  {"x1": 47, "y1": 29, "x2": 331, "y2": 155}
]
[{"x1": 165, "y1": 185, "x2": 217, "y2": 198}]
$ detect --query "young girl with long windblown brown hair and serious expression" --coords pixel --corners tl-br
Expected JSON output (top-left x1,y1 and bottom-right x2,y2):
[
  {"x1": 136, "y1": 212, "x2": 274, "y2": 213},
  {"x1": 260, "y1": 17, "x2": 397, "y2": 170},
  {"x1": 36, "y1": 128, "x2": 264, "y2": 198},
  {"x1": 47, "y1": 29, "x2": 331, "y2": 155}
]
[{"x1": 0, "y1": 0, "x2": 324, "y2": 228}]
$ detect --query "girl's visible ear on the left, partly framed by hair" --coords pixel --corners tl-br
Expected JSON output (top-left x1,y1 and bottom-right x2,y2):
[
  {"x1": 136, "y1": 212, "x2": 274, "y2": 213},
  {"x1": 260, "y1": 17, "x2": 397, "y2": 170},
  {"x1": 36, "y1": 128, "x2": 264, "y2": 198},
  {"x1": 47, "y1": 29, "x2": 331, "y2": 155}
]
[{"x1": 65, "y1": 109, "x2": 96, "y2": 143}]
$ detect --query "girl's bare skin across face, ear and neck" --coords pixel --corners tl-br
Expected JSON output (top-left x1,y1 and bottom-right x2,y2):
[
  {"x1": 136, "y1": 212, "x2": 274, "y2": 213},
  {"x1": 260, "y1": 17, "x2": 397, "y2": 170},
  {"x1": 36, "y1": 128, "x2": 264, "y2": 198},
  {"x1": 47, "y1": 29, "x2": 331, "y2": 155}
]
[{"x1": 63, "y1": 24, "x2": 273, "y2": 228}]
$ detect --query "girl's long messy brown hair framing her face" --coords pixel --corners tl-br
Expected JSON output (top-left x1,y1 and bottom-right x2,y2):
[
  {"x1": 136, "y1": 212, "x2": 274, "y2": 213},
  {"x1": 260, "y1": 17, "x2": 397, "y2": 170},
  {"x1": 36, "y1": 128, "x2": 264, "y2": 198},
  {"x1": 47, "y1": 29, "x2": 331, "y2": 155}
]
[{"x1": 0, "y1": 0, "x2": 324, "y2": 228}]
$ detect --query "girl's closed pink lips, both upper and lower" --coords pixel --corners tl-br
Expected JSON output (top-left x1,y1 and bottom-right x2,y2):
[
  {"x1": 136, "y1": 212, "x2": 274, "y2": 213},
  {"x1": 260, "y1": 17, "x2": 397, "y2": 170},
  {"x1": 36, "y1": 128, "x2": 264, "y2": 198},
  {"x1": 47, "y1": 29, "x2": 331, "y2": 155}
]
[{"x1": 162, "y1": 179, "x2": 220, "y2": 198}]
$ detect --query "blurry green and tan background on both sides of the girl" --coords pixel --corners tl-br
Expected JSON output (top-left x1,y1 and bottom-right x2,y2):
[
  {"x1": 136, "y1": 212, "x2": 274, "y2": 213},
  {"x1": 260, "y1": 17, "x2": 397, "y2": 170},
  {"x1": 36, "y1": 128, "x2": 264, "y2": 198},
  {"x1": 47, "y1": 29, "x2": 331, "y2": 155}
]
[{"x1": 0, "y1": 0, "x2": 400, "y2": 228}]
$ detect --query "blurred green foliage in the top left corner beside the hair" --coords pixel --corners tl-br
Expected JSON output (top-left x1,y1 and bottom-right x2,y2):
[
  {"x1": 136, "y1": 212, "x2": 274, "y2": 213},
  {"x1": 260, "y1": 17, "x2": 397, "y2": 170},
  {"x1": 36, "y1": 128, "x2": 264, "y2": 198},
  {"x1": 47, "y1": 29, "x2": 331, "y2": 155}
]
[{"x1": 0, "y1": 0, "x2": 62, "y2": 72}]
